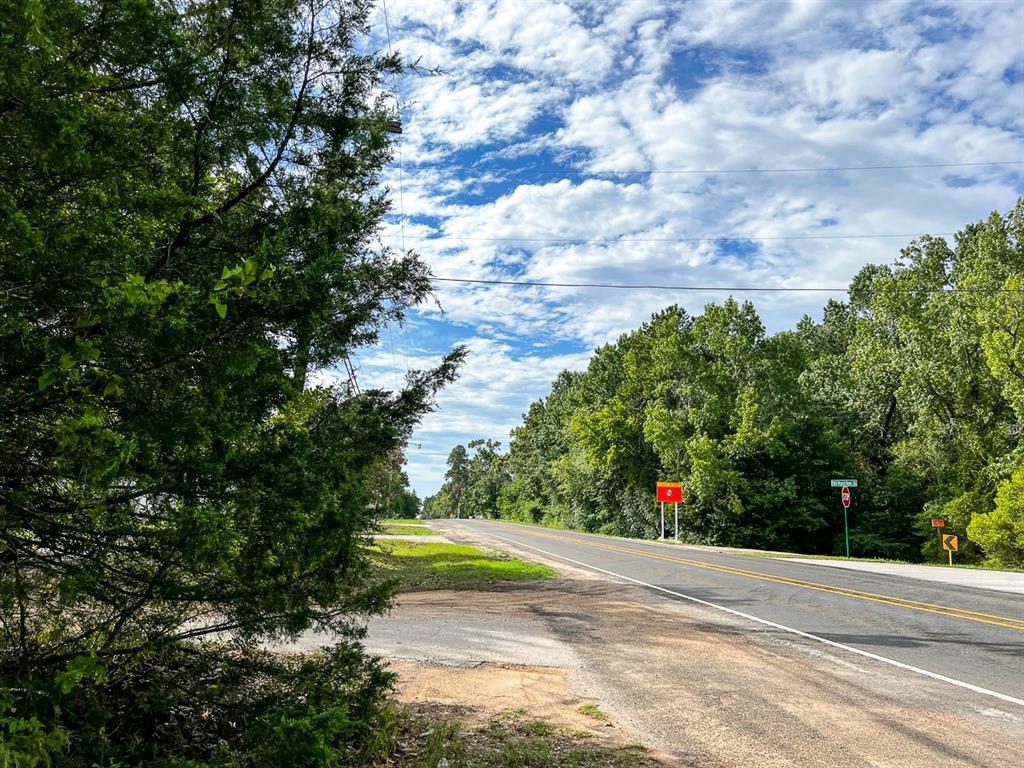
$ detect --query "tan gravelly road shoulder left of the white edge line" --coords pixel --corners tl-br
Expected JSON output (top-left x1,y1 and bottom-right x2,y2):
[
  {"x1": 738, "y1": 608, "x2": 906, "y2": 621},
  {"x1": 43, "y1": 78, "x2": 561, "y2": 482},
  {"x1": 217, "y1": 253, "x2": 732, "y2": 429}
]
[{"x1": 415, "y1": 529, "x2": 1024, "y2": 768}]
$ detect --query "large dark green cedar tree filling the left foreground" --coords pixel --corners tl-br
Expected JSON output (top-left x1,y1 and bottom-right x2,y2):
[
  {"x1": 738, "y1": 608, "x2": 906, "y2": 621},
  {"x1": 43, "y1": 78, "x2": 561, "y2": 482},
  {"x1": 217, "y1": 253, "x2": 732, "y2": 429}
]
[{"x1": 0, "y1": 0, "x2": 459, "y2": 765}]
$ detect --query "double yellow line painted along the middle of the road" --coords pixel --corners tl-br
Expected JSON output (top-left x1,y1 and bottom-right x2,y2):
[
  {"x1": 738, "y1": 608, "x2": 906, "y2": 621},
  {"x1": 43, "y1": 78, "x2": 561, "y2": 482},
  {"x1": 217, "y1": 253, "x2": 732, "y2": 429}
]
[{"x1": 492, "y1": 521, "x2": 1024, "y2": 632}]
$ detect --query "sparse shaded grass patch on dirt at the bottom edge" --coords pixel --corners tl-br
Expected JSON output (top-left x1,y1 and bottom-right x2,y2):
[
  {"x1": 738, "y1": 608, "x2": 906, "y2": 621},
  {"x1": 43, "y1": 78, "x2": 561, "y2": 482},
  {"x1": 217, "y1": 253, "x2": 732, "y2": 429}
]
[{"x1": 387, "y1": 713, "x2": 664, "y2": 768}]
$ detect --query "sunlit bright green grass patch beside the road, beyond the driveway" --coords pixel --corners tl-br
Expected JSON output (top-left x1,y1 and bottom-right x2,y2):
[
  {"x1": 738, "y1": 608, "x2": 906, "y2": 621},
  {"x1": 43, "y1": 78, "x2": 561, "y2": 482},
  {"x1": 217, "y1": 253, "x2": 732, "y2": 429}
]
[{"x1": 370, "y1": 540, "x2": 556, "y2": 591}]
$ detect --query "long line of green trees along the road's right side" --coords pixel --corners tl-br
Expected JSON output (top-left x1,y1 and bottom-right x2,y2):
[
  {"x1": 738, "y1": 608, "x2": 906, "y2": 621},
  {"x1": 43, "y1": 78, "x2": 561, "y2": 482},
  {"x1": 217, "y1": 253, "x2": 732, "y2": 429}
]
[{"x1": 424, "y1": 200, "x2": 1024, "y2": 566}]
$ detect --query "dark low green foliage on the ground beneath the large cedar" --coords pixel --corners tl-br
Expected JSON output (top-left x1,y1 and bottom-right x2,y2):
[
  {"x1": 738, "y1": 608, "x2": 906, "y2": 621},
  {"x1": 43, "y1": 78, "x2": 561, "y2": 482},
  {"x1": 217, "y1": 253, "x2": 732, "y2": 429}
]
[{"x1": 15, "y1": 639, "x2": 392, "y2": 768}]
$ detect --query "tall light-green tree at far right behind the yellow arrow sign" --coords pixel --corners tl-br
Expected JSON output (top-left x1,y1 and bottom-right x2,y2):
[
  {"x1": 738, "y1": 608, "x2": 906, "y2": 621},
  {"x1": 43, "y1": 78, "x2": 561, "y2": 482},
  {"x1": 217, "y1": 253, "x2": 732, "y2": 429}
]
[{"x1": 851, "y1": 203, "x2": 1024, "y2": 559}]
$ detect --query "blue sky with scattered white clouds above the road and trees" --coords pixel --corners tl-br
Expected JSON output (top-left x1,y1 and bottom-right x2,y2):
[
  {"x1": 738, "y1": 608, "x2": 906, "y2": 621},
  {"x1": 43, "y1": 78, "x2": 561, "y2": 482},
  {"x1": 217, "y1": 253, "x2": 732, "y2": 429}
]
[{"x1": 326, "y1": 0, "x2": 1024, "y2": 495}]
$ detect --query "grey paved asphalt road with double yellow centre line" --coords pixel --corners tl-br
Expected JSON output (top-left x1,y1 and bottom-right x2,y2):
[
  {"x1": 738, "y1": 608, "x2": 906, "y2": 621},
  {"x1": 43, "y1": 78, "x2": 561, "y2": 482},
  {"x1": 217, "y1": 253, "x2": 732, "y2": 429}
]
[{"x1": 442, "y1": 520, "x2": 1024, "y2": 709}]
